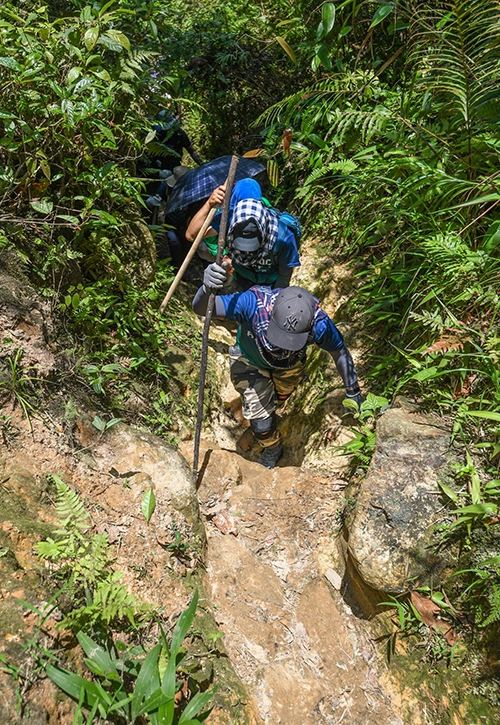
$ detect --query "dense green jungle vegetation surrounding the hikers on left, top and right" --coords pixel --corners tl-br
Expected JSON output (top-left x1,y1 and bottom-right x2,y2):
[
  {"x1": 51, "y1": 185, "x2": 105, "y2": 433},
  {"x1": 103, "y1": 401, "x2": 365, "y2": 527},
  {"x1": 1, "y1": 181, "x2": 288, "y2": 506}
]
[{"x1": 0, "y1": 0, "x2": 500, "y2": 712}]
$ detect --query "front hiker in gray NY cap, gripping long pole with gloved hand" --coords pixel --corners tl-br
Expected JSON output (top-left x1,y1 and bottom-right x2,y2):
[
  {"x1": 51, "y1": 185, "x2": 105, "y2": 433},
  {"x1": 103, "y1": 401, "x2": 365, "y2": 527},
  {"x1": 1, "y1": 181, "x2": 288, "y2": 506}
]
[{"x1": 193, "y1": 278, "x2": 364, "y2": 468}]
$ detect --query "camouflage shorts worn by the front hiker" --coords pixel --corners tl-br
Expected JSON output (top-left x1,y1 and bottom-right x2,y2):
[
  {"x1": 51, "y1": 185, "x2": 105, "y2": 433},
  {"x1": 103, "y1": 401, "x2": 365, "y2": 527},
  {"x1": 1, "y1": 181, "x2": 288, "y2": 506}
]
[{"x1": 229, "y1": 345, "x2": 304, "y2": 420}]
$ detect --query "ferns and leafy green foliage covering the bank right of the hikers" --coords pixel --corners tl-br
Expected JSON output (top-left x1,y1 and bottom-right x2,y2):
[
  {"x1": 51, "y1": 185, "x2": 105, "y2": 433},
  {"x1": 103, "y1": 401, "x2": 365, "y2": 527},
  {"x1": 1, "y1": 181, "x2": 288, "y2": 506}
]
[{"x1": 260, "y1": 0, "x2": 500, "y2": 680}]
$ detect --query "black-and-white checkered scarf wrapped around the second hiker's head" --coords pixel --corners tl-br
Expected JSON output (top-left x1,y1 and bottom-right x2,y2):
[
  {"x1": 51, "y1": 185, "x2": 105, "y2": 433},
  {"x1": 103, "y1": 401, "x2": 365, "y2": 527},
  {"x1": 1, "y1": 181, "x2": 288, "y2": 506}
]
[{"x1": 227, "y1": 199, "x2": 278, "y2": 268}]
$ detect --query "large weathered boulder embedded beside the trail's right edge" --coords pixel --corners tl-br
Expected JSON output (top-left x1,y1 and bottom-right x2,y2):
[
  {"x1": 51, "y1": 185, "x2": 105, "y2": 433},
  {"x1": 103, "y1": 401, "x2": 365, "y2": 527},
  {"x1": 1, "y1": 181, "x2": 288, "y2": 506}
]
[{"x1": 347, "y1": 408, "x2": 450, "y2": 594}]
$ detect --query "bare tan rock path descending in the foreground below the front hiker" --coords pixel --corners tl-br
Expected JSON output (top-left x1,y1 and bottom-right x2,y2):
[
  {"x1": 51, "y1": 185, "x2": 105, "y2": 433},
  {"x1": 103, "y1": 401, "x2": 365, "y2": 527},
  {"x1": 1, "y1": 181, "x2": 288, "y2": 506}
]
[{"x1": 180, "y1": 443, "x2": 402, "y2": 725}]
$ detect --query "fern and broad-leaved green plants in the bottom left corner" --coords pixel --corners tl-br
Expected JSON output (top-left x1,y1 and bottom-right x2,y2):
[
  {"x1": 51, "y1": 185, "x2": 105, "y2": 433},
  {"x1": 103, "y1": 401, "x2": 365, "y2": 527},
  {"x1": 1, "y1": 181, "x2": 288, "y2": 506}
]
[{"x1": 0, "y1": 475, "x2": 216, "y2": 725}]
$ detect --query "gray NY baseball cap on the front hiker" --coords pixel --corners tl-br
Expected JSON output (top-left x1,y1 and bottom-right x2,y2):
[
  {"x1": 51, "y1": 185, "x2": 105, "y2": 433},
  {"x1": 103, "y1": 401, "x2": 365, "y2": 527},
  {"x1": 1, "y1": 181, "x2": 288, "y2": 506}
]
[{"x1": 266, "y1": 287, "x2": 316, "y2": 351}]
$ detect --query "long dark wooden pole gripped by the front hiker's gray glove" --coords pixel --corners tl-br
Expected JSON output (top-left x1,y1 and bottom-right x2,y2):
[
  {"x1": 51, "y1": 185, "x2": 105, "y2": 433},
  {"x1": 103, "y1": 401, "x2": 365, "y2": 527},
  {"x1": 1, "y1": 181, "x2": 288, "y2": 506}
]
[{"x1": 193, "y1": 156, "x2": 238, "y2": 481}]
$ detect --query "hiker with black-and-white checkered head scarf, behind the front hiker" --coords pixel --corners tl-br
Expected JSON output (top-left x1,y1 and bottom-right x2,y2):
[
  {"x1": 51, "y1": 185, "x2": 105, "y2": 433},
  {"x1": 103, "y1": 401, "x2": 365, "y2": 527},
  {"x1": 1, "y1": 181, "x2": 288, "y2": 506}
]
[{"x1": 186, "y1": 179, "x2": 300, "y2": 290}]
